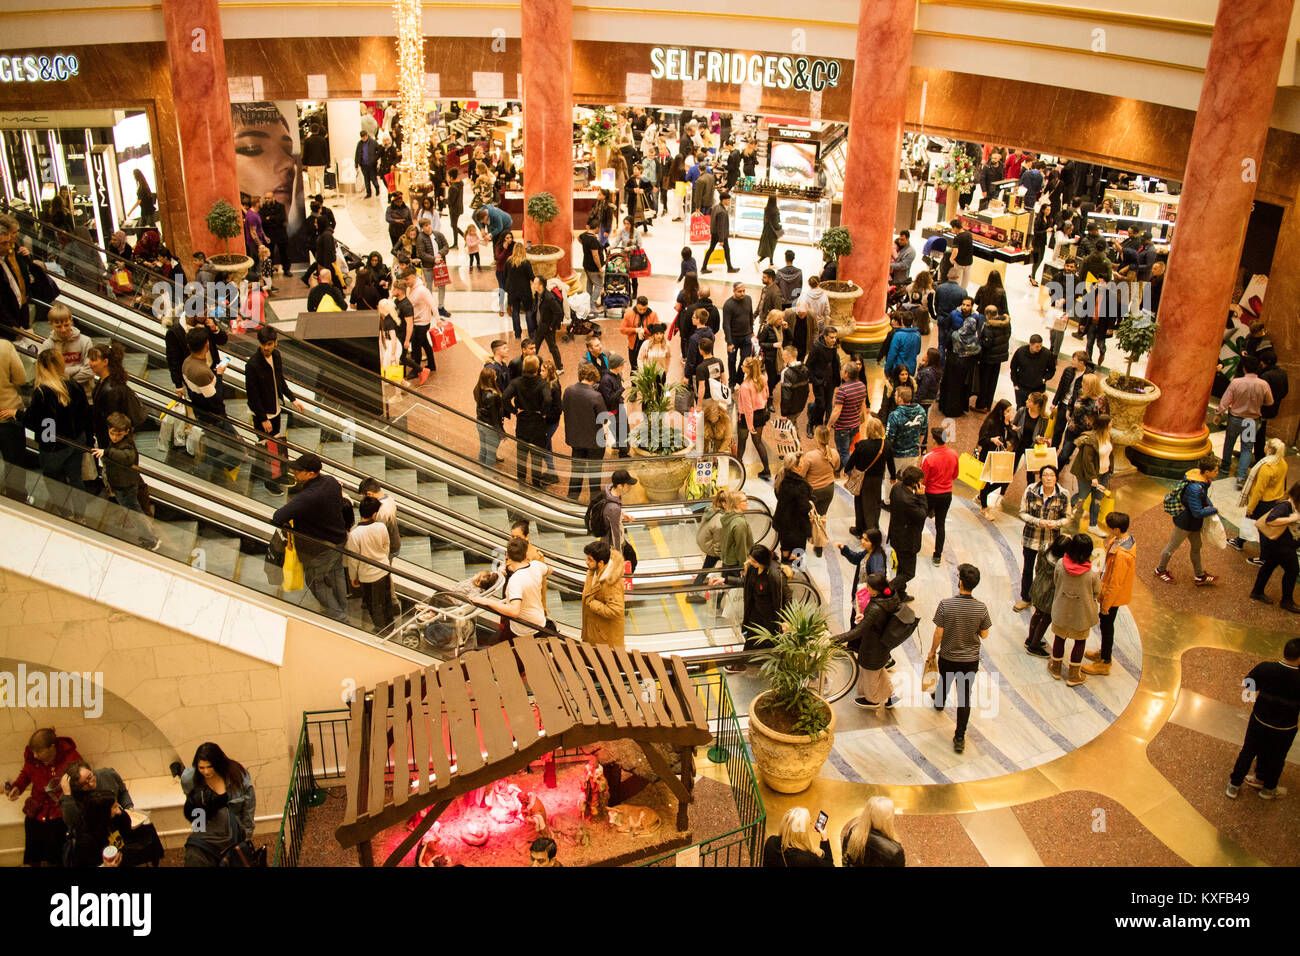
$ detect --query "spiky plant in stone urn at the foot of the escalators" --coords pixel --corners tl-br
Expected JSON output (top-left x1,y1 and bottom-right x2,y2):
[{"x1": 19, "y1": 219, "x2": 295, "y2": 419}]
[{"x1": 628, "y1": 362, "x2": 692, "y2": 502}]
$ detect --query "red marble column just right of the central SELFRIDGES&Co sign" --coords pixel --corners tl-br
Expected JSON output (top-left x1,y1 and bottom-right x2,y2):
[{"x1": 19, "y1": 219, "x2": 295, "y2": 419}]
[{"x1": 836, "y1": 0, "x2": 915, "y2": 341}]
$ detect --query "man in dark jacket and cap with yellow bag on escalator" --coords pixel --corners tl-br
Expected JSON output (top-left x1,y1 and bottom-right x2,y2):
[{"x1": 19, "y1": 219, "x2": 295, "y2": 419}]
[{"x1": 270, "y1": 454, "x2": 355, "y2": 622}]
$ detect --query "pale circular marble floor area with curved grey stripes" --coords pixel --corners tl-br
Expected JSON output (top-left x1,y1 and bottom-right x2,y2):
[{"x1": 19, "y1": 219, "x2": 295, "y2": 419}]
[{"x1": 728, "y1": 481, "x2": 1143, "y2": 784}]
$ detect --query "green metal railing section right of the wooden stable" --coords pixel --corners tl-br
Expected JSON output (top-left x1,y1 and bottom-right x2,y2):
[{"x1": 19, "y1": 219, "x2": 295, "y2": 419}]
[{"x1": 642, "y1": 670, "x2": 767, "y2": 866}]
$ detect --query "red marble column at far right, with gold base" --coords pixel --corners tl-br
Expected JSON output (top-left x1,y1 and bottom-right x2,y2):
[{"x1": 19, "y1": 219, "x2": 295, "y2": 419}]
[{"x1": 1135, "y1": 0, "x2": 1292, "y2": 463}]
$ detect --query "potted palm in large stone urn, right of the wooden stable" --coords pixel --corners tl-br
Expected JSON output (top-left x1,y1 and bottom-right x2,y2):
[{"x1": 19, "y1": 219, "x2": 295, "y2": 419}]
[{"x1": 749, "y1": 601, "x2": 835, "y2": 793}]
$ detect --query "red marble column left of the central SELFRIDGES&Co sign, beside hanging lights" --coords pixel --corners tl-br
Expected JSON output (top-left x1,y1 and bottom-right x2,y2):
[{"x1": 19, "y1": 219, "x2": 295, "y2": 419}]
[{"x1": 521, "y1": 0, "x2": 573, "y2": 276}]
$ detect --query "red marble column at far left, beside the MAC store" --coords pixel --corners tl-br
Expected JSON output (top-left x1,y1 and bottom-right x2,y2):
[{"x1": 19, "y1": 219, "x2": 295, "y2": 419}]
[{"x1": 163, "y1": 0, "x2": 244, "y2": 255}]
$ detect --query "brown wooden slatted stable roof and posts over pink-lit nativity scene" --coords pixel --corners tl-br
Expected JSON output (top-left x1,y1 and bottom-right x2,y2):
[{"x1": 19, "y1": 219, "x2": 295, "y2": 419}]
[{"x1": 334, "y1": 637, "x2": 711, "y2": 866}]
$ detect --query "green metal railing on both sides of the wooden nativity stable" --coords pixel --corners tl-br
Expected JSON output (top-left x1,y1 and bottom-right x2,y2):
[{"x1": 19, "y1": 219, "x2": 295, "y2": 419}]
[{"x1": 273, "y1": 670, "x2": 767, "y2": 866}]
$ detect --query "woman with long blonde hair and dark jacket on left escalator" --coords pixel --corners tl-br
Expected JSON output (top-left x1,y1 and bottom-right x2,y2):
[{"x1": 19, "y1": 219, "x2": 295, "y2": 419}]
[{"x1": 23, "y1": 349, "x2": 91, "y2": 520}]
